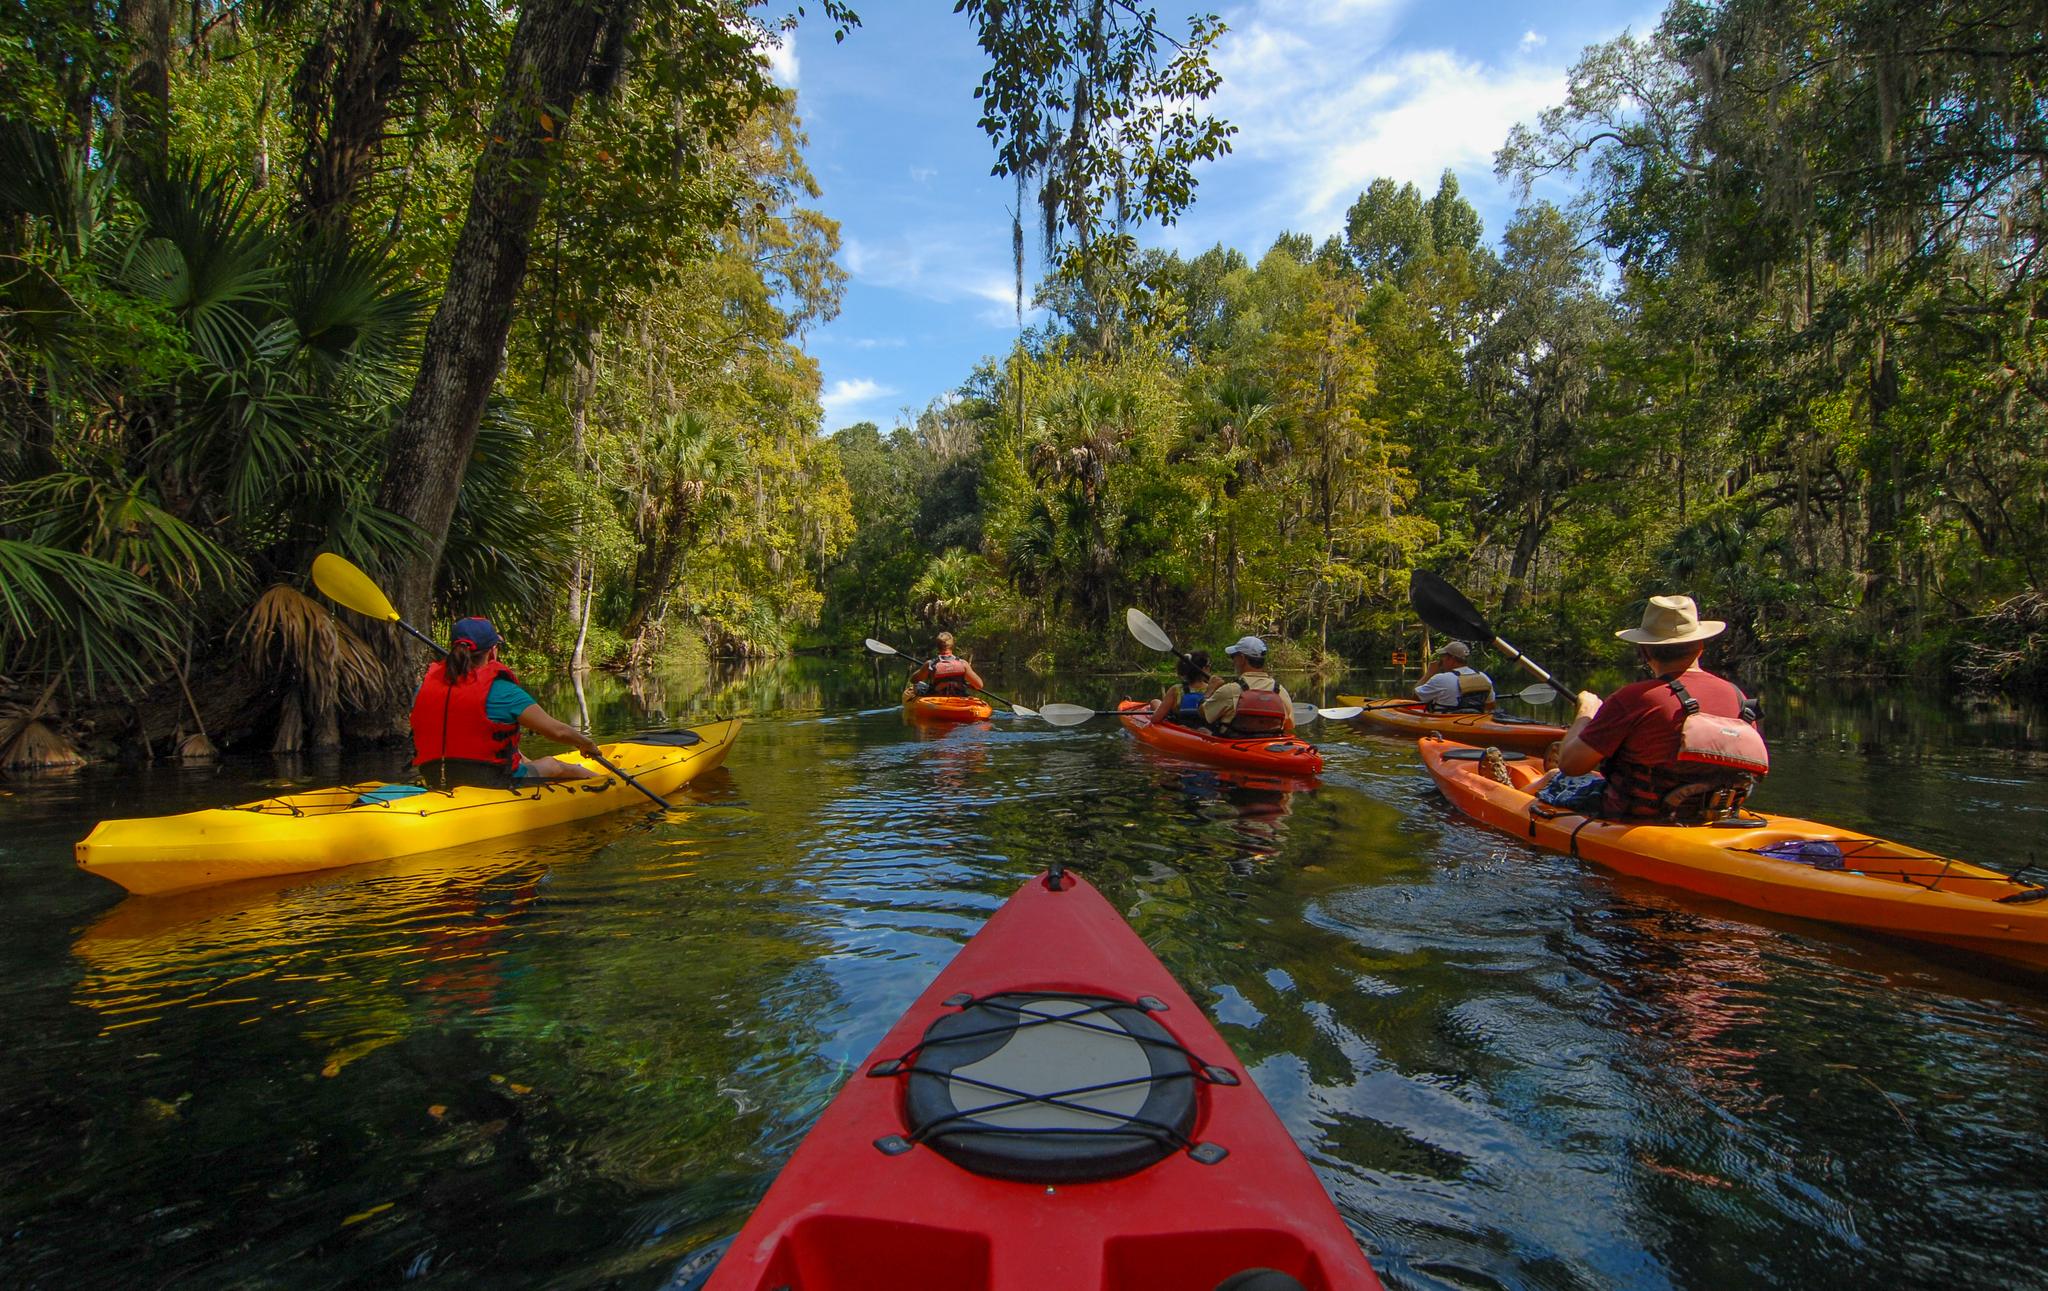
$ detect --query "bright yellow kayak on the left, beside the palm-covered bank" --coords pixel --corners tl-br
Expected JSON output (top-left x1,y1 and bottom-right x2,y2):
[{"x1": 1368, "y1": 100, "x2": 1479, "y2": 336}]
[{"x1": 72, "y1": 719, "x2": 739, "y2": 896}]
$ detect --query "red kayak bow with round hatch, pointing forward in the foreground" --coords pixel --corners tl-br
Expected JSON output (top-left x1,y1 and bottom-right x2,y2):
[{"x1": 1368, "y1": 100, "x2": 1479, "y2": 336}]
[{"x1": 707, "y1": 871, "x2": 1380, "y2": 1291}]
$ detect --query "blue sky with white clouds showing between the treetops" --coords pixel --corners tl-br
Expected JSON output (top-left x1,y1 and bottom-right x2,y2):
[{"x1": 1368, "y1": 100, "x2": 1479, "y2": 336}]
[{"x1": 774, "y1": 0, "x2": 1661, "y2": 430}]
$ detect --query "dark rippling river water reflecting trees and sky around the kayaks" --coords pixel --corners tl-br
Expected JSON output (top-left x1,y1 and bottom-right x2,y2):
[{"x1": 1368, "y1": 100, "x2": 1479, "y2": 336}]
[{"x1": 0, "y1": 660, "x2": 2048, "y2": 1291}]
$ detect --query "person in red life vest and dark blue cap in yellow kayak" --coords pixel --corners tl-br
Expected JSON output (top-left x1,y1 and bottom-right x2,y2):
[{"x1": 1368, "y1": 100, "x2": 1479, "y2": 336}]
[{"x1": 412, "y1": 619, "x2": 598, "y2": 789}]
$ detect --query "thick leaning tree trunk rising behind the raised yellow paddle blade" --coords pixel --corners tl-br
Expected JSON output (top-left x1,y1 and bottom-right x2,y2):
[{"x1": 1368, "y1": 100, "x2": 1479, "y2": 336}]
[{"x1": 377, "y1": 0, "x2": 616, "y2": 734}]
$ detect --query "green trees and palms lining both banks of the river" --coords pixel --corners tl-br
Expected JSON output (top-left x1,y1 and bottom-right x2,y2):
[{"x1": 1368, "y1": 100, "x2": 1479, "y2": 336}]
[{"x1": 0, "y1": 0, "x2": 2048, "y2": 764}]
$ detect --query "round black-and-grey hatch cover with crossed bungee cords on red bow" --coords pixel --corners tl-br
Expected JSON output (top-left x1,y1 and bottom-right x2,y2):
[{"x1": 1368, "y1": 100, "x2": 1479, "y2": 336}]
[{"x1": 868, "y1": 992, "x2": 1237, "y2": 1184}]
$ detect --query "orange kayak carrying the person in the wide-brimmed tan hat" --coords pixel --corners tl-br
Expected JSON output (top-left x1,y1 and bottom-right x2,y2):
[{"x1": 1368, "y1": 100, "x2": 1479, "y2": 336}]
[{"x1": 1419, "y1": 736, "x2": 2048, "y2": 969}]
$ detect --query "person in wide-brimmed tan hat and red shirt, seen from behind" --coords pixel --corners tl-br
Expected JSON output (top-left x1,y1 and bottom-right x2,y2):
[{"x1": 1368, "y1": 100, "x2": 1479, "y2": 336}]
[{"x1": 1556, "y1": 596, "x2": 1769, "y2": 824}]
